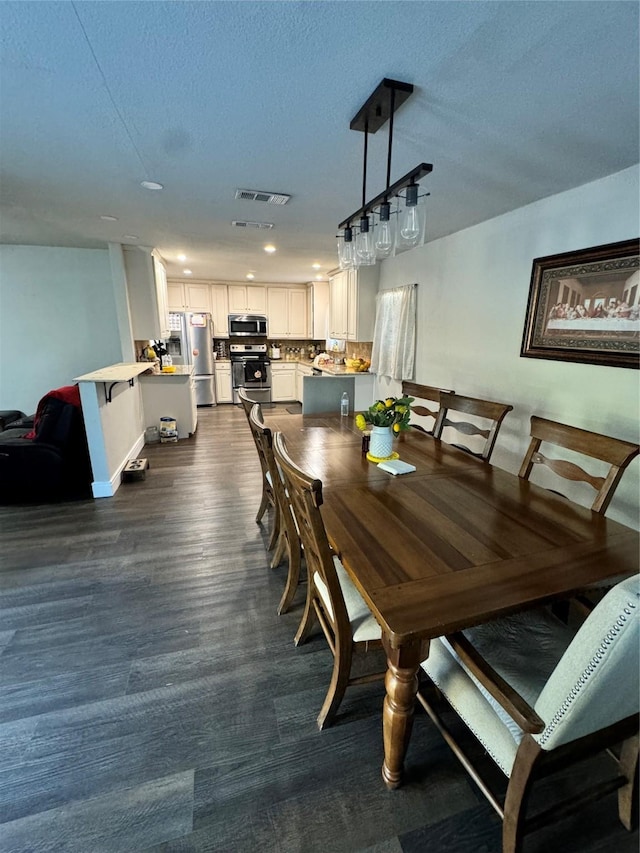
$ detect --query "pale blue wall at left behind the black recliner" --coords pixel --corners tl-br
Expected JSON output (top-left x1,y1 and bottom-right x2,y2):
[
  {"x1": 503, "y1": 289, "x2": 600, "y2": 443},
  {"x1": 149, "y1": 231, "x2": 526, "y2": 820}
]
[{"x1": 0, "y1": 246, "x2": 123, "y2": 414}]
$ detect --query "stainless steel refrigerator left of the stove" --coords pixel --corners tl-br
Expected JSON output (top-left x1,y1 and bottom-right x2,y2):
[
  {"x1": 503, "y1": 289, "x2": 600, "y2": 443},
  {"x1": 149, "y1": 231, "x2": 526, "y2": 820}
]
[{"x1": 167, "y1": 312, "x2": 216, "y2": 406}]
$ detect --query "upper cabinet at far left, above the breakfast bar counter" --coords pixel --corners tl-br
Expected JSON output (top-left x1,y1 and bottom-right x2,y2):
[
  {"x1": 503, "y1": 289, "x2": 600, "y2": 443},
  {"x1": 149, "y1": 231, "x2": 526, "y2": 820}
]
[{"x1": 122, "y1": 246, "x2": 169, "y2": 341}]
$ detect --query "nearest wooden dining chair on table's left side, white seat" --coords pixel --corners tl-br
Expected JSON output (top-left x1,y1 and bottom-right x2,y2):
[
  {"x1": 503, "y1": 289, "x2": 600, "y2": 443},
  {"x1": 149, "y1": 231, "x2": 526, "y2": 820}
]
[{"x1": 273, "y1": 432, "x2": 386, "y2": 729}]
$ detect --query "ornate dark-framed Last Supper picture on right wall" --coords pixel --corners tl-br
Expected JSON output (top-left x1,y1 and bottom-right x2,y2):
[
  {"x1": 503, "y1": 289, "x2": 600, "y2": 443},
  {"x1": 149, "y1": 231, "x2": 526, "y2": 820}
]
[{"x1": 520, "y1": 240, "x2": 640, "y2": 369}]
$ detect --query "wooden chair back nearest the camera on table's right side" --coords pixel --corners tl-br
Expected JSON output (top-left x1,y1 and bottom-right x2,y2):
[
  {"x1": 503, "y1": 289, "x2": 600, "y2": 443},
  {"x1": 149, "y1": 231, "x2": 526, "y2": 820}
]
[{"x1": 518, "y1": 415, "x2": 640, "y2": 514}]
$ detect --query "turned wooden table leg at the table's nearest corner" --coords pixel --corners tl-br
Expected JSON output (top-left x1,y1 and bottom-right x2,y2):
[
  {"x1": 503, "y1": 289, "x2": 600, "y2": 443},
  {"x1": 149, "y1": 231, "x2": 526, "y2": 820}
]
[{"x1": 382, "y1": 636, "x2": 428, "y2": 789}]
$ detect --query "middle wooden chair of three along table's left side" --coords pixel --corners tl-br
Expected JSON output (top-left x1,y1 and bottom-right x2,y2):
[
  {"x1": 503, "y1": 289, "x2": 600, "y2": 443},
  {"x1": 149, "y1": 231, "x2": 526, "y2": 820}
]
[{"x1": 249, "y1": 403, "x2": 302, "y2": 614}]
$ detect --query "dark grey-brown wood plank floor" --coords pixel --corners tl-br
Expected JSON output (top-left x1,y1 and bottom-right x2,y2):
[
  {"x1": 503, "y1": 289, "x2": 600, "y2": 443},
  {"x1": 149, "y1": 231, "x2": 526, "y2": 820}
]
[{"x1": 0, "y1": 406, "x2": 638, "y2": 853}]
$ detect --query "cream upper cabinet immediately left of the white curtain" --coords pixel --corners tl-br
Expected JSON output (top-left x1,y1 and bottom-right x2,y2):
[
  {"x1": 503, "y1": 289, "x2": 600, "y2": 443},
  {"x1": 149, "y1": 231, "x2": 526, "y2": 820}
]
[{"x1": 329, "y1": 266, "x2": 378, "y2": 341}]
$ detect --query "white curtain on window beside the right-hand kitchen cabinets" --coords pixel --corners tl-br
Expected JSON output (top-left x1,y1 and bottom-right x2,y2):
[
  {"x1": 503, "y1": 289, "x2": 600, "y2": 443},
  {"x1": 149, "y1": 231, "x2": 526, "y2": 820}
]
[{"x1": 371, "y1": 284, "x2": 416, "y2": 381}]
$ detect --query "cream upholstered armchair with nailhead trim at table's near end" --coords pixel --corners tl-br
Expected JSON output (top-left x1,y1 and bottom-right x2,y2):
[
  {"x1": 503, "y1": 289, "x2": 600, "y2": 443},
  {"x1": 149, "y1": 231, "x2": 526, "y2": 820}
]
[{"x1": 418, "y1": 575, "x2": 640, "y2": 853}]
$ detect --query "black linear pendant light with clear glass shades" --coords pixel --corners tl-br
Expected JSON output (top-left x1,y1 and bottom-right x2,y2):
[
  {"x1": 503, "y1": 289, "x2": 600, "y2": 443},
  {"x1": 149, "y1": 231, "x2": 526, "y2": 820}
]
[{"x1": 338, "y1": 77, "x2": 433, "y2": 269}]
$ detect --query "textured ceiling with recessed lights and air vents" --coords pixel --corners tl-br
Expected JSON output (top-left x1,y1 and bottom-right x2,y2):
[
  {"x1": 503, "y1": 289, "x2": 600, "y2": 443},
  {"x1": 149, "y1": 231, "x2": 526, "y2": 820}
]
[{"x1": 0, "y1": 0, "x2": 639, "y2": 282}]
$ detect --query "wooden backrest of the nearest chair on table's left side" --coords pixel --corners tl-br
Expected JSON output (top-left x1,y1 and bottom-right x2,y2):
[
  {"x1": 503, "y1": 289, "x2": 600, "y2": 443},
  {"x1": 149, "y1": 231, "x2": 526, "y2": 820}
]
[{"x1": 273, "y1": 432, "x2": 351, "y2": 642}]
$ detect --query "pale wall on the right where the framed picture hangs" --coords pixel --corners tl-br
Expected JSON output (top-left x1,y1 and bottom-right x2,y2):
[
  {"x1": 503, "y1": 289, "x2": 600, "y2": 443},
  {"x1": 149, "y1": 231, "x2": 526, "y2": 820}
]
[{"x1": 377, "y1": 166, "x2": 640, "y2": 528}]
